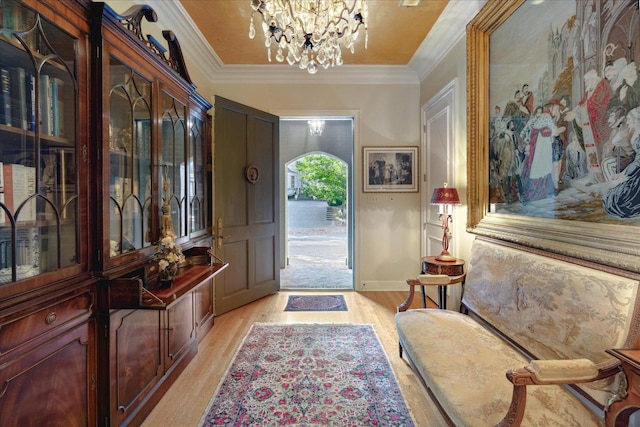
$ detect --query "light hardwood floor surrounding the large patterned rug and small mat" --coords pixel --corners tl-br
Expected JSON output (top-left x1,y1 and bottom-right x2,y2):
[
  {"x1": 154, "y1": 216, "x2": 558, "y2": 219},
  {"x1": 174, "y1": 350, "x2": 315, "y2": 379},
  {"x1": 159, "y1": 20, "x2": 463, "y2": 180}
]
[{"x1": 142, "y1": 291, "x2": 446, "y2": 427}]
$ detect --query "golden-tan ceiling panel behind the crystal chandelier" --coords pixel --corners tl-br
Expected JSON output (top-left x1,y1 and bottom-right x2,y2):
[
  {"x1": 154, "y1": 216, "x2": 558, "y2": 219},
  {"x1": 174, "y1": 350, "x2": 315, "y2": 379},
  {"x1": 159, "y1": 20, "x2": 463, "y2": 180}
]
[{"x1": 180, "y1": 0, "x2": 448, "y2": 66}]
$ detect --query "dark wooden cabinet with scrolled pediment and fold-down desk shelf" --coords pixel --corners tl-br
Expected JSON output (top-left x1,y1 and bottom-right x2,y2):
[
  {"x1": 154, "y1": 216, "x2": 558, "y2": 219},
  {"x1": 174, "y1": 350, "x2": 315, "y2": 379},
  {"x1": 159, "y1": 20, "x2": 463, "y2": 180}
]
[{"x1": 91, "y1": 3, "x2": 226, "y2": 426}]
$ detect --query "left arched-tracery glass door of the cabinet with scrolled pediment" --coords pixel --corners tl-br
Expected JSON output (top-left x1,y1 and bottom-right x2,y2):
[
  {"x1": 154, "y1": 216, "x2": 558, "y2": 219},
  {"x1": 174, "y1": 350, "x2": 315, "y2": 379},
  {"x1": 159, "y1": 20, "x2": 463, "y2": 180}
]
[{"x1": 109, "y1": 57, "x2": 154, "y2": 257}]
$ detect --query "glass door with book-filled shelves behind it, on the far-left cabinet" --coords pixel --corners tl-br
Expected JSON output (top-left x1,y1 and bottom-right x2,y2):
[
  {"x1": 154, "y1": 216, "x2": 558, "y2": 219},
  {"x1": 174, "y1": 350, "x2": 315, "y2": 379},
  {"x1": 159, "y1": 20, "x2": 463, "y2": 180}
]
[{"x1": 0, "y1": 0, "x2": 80, "y2": 283}]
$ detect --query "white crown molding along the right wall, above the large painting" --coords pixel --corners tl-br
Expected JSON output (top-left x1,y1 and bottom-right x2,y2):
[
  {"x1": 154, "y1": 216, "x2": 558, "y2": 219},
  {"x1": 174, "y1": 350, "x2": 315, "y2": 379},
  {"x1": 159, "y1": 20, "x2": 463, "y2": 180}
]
[{"x1": 409, "y1": 0, "x2": 487, "y2": 81}]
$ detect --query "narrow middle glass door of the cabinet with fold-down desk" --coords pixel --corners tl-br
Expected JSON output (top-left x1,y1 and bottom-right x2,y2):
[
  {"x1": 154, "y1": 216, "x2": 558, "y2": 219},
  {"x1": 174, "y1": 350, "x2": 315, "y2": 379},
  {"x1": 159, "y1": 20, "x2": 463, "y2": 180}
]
[{"x1": 159, "y1": 92, "x2": 188, "y2": 237}]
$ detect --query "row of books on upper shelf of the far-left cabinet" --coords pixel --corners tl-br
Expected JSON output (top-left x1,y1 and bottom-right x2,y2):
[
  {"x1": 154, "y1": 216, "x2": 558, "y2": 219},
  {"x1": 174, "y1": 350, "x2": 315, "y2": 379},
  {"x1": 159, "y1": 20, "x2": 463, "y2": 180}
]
[{"x1": 0, "y1": 67, "x2": 64, "y2": 137}]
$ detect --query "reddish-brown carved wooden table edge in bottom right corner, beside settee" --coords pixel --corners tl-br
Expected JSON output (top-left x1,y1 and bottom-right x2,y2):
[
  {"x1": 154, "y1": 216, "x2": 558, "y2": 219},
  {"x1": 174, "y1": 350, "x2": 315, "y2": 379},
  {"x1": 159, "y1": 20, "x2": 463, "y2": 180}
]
[{"x1": 606, "y1": 349, "x2": 640, "y2": 427}]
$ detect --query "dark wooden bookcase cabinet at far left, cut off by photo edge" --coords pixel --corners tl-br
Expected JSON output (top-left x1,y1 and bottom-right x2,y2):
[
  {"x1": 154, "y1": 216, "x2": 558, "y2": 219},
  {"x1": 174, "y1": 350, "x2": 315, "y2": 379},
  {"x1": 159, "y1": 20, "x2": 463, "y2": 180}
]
[{"x1": 0, "y1": 0, "x2": 97, "y2": 427}]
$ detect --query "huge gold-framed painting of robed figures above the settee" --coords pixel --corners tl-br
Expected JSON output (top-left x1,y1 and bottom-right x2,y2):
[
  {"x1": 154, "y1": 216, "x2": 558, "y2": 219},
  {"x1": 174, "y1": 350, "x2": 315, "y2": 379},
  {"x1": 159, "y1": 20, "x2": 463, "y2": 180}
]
[{"x1": 467, "y1": 0, "x2": 640, "y2": 272}]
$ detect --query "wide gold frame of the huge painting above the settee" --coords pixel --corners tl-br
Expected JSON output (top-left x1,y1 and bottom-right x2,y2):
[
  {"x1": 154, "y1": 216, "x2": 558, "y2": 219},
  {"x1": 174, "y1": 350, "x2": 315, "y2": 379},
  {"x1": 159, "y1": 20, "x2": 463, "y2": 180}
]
[{"x1": 467, "y1": 0, "x2": 640, "y2": 273}]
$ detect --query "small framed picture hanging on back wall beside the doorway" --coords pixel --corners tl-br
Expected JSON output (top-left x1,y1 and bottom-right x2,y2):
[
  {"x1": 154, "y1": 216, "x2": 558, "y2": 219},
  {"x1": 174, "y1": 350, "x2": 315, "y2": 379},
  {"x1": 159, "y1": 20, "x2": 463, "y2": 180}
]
[{"x1": 362, "y1": 147, "x2": 419, "y2": 193}]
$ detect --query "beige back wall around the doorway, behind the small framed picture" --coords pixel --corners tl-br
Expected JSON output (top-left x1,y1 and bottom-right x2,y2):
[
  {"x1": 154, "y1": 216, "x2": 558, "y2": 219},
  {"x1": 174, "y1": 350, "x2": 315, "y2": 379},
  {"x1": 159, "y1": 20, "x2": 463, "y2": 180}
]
[{"x1": 208, "y1": 83, "x2": 420, "y2": 290}]
